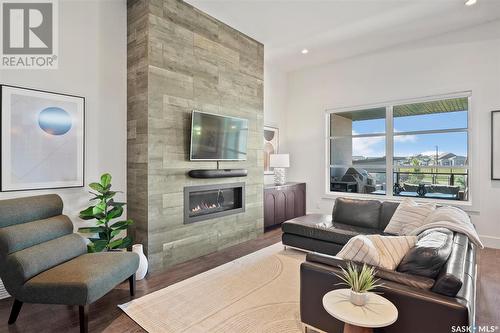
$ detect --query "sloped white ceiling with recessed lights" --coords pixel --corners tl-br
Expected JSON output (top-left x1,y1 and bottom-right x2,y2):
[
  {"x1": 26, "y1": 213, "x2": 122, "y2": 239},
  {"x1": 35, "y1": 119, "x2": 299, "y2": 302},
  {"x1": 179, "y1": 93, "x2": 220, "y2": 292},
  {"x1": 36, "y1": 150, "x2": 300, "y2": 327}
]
[{"x1": 186, "y1": 0, "x2": 500, "y2": 71}]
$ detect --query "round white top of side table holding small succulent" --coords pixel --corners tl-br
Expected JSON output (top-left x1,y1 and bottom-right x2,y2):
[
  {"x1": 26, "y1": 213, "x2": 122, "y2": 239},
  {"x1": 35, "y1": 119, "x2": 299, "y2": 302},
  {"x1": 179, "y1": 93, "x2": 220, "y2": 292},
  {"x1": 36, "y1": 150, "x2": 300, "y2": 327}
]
[{"x1": 323, "y1": 289, "x2": 398, "y2": 333}]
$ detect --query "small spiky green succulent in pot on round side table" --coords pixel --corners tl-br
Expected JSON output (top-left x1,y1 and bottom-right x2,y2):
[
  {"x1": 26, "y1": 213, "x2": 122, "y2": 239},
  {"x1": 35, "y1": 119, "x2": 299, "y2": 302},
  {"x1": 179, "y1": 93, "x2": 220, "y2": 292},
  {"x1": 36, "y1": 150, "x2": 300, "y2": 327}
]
[{"x1": 335, "y1": 262, "x2": 382, "y2": 306}]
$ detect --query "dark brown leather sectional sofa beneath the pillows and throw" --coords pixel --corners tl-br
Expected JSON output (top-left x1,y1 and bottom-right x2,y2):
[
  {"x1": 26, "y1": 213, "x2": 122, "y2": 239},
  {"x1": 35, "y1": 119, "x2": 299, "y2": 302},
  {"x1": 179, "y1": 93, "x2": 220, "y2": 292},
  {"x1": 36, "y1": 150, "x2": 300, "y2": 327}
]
[{"x1": 282, "y1": 198, "x2": 476, "y2": 333}]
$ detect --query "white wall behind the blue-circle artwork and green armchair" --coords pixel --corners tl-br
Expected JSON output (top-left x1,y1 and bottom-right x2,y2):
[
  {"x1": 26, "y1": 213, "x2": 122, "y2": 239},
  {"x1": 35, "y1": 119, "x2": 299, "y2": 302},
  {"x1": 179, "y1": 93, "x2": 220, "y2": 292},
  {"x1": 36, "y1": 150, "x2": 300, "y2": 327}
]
[{"x1": 0, "y1": 0, "x2": 127, "y2": 226}]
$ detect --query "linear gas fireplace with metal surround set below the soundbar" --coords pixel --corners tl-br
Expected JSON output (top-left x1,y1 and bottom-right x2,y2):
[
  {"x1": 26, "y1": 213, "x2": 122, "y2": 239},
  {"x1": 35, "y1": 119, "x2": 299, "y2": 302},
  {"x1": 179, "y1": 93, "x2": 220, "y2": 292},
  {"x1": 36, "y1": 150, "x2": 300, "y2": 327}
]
[{"x1": 184, "y1": 183, "x2": 245, "y2": 224}]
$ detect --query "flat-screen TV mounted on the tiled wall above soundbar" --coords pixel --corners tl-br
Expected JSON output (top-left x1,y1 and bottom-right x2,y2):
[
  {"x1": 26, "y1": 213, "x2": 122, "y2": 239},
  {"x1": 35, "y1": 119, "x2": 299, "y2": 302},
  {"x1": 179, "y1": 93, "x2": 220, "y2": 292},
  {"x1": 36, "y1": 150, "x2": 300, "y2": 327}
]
[{"x1": 191, "y1": 111, "x2": 248, "y2": 161}]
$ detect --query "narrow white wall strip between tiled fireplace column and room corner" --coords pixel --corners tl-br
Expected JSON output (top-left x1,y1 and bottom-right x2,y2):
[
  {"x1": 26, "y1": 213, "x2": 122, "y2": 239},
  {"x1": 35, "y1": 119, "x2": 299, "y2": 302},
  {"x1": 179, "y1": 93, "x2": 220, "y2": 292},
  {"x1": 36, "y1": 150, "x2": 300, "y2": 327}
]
[{"x1": 264, "y1": 63, "x2": 291, "y2": 184}]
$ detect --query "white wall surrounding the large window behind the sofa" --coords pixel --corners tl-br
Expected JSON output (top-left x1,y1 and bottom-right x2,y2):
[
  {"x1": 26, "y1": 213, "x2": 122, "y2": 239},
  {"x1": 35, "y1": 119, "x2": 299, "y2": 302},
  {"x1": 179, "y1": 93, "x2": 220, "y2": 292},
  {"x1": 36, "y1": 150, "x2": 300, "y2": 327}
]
[{"x1": 286, "y1": 21, "x2": 500, "y2": 247}]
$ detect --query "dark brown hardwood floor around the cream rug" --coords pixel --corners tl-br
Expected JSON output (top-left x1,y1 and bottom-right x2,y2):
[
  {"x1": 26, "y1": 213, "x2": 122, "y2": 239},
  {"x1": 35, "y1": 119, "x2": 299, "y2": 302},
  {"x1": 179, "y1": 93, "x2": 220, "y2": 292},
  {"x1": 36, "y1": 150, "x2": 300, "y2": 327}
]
[{"x1": 0, "y1": 229, "x2": 500, "y2": 333}]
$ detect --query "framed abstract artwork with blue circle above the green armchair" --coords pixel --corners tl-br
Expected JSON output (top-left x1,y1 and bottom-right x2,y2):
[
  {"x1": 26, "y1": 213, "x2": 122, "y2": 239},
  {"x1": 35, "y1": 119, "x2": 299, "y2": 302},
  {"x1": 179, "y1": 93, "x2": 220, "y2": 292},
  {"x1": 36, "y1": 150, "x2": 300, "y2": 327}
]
[{"x1": 0, "y1": 85, "x2": 85, "y2": 191}]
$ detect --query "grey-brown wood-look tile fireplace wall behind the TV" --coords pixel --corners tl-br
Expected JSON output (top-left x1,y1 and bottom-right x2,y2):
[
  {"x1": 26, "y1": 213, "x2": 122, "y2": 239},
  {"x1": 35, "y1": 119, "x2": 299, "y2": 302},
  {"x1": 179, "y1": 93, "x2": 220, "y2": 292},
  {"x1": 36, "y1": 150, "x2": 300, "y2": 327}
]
[{"x1": 127, "y1": 0, "x2": 264, "y2": 270}]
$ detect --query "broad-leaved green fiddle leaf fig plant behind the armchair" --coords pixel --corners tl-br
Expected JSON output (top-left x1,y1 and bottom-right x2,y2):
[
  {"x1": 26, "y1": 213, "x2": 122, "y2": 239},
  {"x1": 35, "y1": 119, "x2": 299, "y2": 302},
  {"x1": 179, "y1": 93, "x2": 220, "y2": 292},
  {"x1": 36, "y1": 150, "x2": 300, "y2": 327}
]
[{"x1": 78, "y1": 173, "x2": 133, "y2": 252}]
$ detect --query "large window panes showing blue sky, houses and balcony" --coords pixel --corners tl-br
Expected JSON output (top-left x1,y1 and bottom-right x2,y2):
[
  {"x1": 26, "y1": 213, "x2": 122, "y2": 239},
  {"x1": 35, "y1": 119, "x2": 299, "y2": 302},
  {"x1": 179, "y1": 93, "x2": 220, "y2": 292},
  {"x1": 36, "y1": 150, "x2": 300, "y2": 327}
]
[{"x1": 327, "y1": 94, "x2": 469, "y2": 201}]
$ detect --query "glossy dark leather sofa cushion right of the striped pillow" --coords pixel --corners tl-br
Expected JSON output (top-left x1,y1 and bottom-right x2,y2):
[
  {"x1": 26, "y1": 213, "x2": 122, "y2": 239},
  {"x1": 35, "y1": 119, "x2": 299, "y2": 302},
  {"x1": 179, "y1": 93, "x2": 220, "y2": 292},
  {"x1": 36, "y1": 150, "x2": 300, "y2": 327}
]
[{"x1": 398, "y1": 228, "x2": 453, "y2": 278}]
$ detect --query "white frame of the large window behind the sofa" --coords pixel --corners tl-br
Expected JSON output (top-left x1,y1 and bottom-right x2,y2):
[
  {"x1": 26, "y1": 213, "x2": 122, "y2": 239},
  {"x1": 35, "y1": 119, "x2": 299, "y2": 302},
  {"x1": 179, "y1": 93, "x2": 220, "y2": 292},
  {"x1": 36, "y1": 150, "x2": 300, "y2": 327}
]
[{"x1": 323, "y1": 91, "x2": 475, "y2": 207}]
